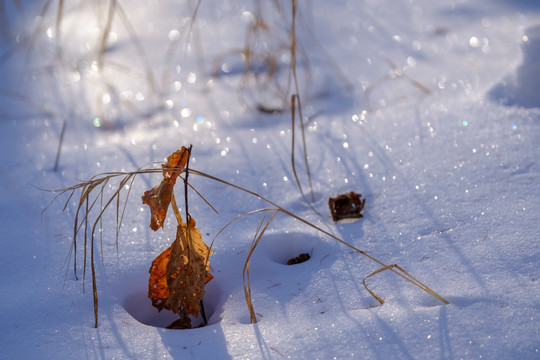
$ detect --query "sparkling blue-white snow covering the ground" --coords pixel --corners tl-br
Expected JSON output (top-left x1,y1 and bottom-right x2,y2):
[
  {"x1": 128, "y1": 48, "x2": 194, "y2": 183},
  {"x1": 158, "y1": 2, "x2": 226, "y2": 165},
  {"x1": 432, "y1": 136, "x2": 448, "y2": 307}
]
[{"x1": 0, "y1": 0, "x2": 540, "y2": 359}]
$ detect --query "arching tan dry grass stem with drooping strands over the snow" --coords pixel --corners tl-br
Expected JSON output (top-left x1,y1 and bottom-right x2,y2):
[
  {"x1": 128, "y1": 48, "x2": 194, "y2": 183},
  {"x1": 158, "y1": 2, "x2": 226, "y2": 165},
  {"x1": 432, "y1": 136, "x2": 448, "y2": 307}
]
[{"x1": 48, "y1": 150, "x2": 448, "y2": 327}]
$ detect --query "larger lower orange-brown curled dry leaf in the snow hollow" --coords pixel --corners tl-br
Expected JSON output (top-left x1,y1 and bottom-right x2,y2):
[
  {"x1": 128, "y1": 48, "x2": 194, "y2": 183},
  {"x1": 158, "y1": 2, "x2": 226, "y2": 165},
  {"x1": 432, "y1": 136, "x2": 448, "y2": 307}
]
[{"x1": 148, "y1": 215, "x2": 213, "y2": 328}]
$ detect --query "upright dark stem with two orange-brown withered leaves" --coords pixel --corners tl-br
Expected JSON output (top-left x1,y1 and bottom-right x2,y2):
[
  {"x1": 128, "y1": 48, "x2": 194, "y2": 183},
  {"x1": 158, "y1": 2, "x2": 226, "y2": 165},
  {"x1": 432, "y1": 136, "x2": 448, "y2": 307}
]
[{"x1": 146, "y1": 146, "x2": 213, "y2": 329}]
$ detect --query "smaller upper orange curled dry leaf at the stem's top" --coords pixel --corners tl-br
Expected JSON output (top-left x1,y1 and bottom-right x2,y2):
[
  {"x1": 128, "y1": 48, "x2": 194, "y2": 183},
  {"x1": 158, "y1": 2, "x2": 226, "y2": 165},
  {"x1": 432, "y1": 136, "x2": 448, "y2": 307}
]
[{"x1": 142, "y1": 146, "x2": 189, "y2": 231}]
